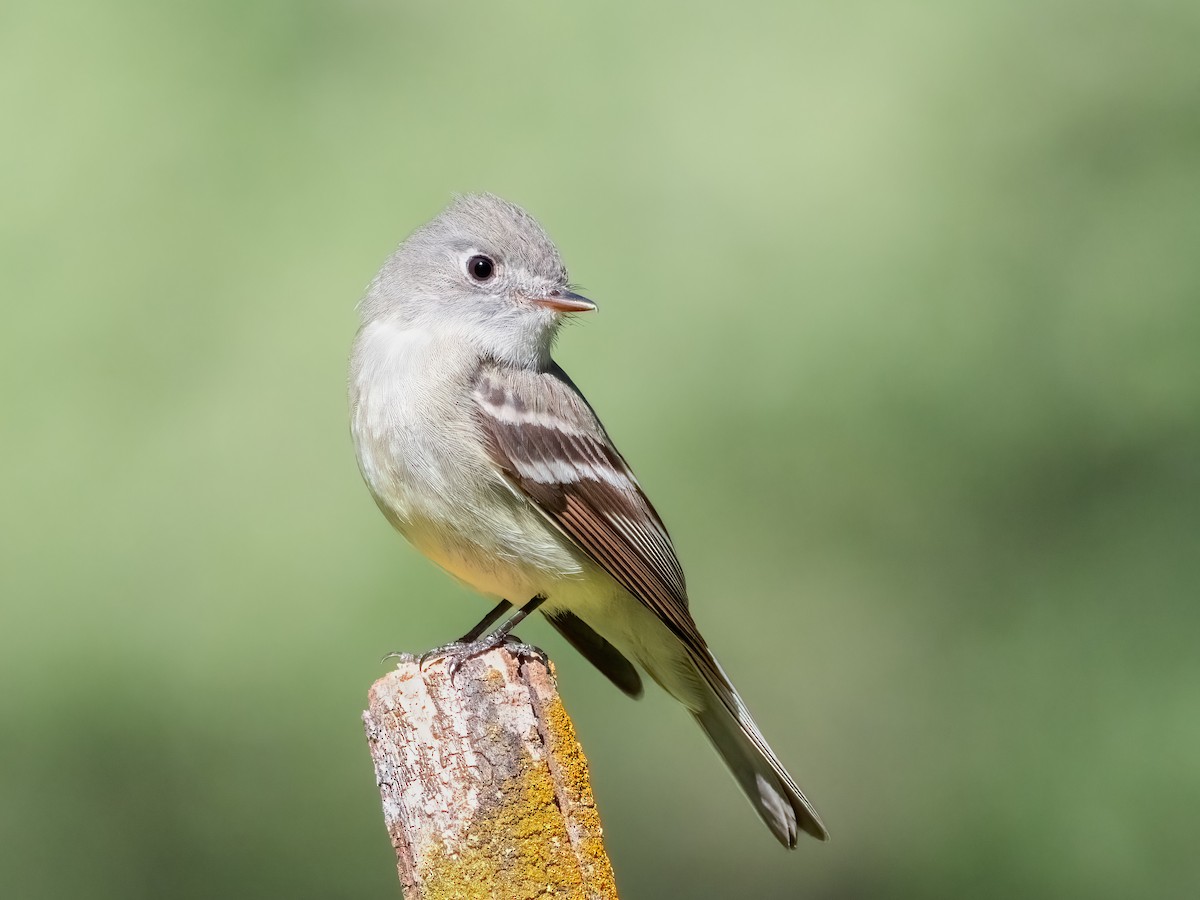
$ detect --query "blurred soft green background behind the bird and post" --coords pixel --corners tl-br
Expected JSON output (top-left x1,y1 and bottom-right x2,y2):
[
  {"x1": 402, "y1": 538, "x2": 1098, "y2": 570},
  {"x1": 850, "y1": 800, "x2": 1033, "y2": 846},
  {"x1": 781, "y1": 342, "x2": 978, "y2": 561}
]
[{"x1": 0, "y1": 0, "x2": 1200, "y2": 899}]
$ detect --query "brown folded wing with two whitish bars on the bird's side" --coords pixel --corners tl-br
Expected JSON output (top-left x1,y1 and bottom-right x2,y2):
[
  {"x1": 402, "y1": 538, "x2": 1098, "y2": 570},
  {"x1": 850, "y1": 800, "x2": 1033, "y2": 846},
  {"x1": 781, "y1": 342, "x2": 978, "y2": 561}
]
[{"x1": 473, "y1": 364, "x2": 708, "y2": 656}]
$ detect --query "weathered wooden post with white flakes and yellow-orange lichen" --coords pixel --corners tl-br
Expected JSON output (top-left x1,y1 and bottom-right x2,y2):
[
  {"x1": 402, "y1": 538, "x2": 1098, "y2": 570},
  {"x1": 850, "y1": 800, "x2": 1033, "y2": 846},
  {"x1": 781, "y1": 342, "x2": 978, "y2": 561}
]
[{"x1": 362, "y1": 647, "x2": 617, "y2": 900}]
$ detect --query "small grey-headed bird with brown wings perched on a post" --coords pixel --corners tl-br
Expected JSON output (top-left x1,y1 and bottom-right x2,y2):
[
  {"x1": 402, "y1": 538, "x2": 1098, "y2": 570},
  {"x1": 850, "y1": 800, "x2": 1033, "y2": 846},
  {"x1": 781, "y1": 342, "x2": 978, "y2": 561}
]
[{"x1": 349, "y1": 194, "x2": 827, "y2": 847}]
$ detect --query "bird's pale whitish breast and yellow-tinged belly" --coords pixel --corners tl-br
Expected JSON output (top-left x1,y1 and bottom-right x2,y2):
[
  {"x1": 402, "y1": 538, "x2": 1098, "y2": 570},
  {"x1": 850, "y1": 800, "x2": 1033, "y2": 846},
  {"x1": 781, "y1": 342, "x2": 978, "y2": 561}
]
[{"x1": 349, "y1": 323, "x2": 582, "y2": 602}]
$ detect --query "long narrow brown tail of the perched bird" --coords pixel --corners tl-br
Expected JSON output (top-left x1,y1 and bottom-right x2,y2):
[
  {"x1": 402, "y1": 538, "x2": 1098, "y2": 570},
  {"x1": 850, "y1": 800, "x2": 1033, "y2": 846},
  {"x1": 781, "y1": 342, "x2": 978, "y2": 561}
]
[{"x1": 691, "y1": 654, "x2": 829, "y2": 847}]
